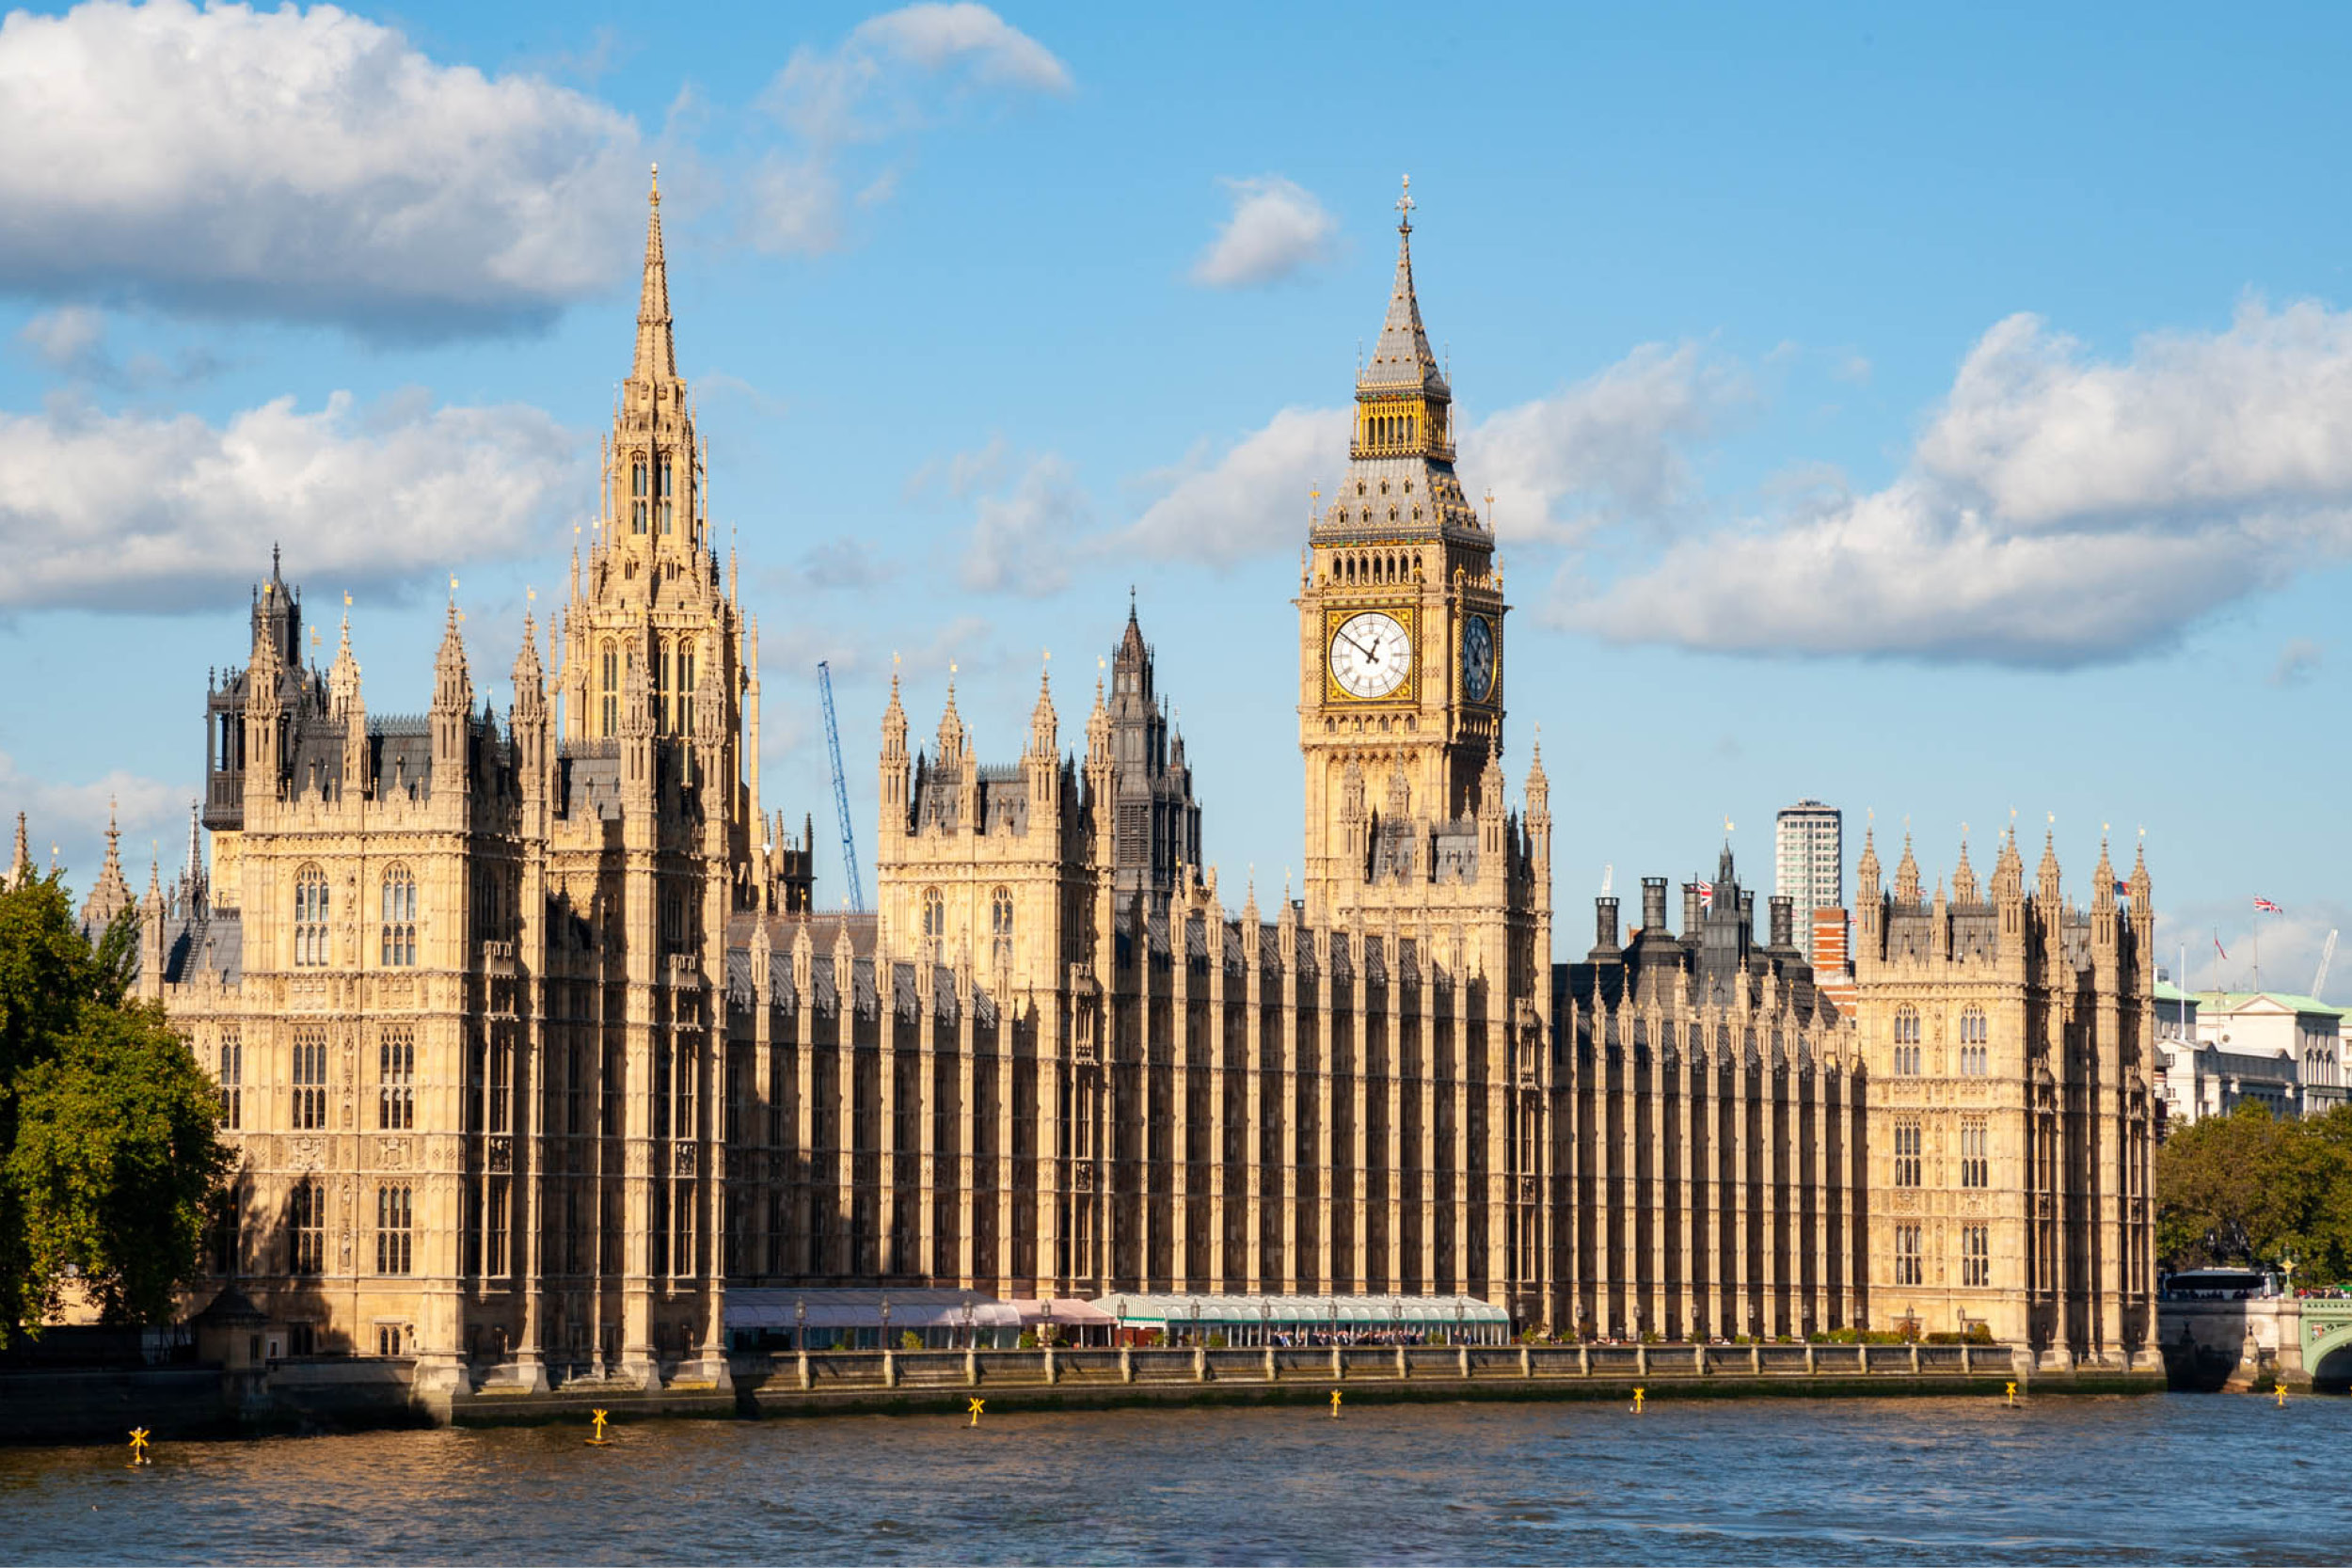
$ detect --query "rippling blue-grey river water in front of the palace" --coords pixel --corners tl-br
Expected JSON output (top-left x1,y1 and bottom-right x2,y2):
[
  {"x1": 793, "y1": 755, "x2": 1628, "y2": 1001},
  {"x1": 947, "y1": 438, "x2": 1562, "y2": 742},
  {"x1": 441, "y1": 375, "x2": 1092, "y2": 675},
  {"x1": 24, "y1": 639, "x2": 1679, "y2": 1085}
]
[{"x1": 0, "y1": 1394, "x2": 2352, "y2": 1566}]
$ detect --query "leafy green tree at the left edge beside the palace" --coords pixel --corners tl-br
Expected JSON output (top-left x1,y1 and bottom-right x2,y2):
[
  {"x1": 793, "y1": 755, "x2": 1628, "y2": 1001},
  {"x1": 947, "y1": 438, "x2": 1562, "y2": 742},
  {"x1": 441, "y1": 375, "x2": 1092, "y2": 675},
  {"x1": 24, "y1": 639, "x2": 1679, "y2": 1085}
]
[{"x1": 0, "y1": 872, "x2": 230, "y2": 1342}]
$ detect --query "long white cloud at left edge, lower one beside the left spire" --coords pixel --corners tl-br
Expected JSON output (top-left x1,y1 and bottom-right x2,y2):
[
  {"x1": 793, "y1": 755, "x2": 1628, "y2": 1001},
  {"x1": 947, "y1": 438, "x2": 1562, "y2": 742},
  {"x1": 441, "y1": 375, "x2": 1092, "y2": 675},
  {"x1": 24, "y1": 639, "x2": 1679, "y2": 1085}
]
[{"x1": 0, "y1": 392, "x2": 593, "y2": 611}]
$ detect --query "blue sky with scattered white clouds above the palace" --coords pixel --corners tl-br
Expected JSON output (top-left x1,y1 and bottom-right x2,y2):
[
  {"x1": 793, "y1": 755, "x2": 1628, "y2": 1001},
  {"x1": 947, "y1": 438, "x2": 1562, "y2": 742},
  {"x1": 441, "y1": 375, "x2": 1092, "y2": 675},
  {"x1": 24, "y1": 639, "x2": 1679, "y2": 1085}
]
[{"x1": 0, "y1": 5, "x2": 2352, "y2": 999}]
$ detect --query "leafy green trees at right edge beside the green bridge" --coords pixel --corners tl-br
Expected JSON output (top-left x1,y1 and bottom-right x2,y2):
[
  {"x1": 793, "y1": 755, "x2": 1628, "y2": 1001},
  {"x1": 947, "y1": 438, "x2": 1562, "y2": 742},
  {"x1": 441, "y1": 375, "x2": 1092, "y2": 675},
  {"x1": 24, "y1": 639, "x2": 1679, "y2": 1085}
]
[{"x1": 2157, "y1": 1101, "x2": 2352, "y2": 1286}]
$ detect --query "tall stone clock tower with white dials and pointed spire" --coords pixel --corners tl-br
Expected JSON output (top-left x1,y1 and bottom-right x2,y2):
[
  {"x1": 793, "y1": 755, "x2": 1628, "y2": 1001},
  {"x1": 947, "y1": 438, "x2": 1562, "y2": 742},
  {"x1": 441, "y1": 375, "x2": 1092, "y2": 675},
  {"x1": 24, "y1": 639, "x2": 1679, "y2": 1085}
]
[{"x1": 1298, "y1": 181, "x2": 1508, "y2": 917}]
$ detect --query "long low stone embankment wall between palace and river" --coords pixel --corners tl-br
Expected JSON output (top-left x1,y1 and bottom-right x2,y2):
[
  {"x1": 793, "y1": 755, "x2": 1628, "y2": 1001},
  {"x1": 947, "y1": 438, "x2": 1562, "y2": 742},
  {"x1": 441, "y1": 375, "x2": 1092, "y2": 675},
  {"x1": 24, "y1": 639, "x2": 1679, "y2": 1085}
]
[{"x1": 0, "y1": 1345, "x2": 2164, "y2": 1444}]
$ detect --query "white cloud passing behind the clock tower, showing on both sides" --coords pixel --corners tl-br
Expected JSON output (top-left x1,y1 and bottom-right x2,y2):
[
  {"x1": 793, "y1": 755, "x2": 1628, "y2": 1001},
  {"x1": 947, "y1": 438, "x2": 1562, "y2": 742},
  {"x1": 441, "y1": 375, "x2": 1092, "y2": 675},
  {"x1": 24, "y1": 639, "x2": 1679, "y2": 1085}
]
[{"x1": 1122, "y1": 343, "x2": 1748, "y2": 564}]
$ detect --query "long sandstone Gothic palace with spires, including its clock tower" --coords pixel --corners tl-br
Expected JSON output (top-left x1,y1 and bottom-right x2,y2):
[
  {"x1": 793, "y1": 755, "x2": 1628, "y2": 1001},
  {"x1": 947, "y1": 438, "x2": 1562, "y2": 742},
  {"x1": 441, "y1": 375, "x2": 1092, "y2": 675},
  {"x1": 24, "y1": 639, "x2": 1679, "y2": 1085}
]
[{"x1": 37, "y1": 175, "x2": 2154, "y2": 1387}]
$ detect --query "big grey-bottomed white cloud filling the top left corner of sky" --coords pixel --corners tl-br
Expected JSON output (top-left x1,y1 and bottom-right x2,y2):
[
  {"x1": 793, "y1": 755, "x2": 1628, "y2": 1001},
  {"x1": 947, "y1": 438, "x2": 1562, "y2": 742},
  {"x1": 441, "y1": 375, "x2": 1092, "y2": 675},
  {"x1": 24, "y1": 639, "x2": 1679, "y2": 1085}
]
[{"x1": 0, "y1": 0, "x2": 644, "y2": 334}]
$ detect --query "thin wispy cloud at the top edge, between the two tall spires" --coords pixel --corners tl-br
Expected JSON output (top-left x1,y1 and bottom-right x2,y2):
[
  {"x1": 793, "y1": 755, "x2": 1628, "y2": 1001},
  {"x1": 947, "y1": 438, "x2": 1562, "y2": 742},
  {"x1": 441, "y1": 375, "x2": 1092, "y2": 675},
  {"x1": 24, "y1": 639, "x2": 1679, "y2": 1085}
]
[{"x1": 746, "y1": 2, "x2": 1073, "y2": 256}]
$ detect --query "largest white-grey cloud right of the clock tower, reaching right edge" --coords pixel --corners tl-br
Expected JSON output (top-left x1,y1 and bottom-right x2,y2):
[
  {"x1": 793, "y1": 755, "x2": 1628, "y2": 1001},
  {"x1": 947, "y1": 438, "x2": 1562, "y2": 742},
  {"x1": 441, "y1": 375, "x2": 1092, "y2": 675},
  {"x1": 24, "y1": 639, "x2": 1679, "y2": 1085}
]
[{"x1": 1557, "y1": 301, "x2": 2352, "y2": 668}]
